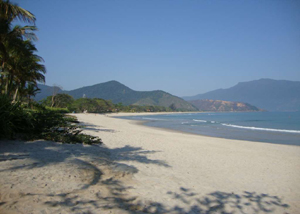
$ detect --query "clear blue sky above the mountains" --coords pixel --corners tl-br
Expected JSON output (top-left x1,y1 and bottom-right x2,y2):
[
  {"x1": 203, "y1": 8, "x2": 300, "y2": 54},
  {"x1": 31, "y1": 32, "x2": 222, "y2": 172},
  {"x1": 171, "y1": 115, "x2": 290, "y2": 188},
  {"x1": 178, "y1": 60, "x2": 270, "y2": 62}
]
[{"x1": 18, "y1": 0, "x2": 300, "y2": 96}]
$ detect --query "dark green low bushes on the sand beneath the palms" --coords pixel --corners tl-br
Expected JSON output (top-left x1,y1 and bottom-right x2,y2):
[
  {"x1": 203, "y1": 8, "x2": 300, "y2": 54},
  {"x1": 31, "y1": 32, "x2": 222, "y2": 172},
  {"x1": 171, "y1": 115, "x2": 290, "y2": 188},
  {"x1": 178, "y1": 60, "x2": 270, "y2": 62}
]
[{"x1": 0, "y1": 96, "x2": 102, "y2": 144}]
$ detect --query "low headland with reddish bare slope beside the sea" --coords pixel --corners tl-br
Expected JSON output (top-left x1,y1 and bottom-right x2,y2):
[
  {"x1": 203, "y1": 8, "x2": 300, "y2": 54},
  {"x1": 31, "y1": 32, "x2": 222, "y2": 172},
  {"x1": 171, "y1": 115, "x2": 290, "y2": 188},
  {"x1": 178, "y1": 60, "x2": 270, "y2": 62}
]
[{"x1": 189, "y1": 100, "x2": 262, "y2": 112}]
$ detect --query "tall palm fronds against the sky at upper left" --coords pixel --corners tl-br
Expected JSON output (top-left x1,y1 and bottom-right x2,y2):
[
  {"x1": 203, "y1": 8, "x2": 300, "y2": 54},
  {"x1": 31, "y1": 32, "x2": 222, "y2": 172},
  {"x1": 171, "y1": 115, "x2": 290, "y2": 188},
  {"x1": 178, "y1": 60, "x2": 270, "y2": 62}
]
[{"x1": 0, "y1": 0, "x2": 46, "y2": 101}]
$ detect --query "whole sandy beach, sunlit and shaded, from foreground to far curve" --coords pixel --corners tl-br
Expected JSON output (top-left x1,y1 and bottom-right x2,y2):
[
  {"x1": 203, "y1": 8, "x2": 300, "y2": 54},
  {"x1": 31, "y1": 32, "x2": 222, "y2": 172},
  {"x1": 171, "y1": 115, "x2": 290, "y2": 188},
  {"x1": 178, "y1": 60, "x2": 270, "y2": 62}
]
[{"x1": 0, "y1": 114, "x2": 300, "y2": 213}]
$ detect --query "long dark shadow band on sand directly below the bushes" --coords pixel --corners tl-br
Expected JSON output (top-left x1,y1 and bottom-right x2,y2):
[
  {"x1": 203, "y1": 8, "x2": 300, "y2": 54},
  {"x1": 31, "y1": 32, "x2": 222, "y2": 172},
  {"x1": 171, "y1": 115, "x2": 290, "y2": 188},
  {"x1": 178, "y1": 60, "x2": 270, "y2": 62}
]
[{"x1": 0, "y1": 140, "x2": 170, "y2": 172}]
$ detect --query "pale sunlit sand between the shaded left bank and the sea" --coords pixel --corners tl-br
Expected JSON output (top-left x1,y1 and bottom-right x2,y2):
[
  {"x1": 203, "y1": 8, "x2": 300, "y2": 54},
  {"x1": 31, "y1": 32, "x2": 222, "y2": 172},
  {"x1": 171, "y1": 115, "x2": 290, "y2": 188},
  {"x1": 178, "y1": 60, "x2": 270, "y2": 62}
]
[{"x1": 76, "y1": 114, "x2": 300, "y2": 213}]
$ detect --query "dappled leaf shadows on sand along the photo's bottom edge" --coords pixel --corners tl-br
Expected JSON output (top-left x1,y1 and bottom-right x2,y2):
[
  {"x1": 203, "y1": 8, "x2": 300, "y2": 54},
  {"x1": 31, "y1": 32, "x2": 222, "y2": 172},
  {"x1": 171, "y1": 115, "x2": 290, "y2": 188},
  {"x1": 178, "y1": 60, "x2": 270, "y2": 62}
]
[{"x1": 48, "y1": 186, "x2": 289, "y2": 214}]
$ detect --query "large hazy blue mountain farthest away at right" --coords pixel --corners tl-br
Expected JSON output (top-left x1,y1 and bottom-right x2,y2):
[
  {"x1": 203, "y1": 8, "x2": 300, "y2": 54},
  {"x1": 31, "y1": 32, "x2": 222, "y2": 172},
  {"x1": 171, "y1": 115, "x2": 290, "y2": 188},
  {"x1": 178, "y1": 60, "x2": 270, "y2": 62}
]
[{"x1": 184, "y1": 79, "x2": 300, "y2": 111}]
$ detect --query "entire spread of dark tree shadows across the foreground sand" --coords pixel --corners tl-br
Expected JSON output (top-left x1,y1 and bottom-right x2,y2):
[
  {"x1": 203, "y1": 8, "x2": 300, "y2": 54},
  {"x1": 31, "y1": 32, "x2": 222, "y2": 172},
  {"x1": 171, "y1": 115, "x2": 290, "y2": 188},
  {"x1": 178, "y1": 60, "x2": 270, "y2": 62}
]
[{"x1": 0, "y1": 141, "x2": 289, "y2": 214}]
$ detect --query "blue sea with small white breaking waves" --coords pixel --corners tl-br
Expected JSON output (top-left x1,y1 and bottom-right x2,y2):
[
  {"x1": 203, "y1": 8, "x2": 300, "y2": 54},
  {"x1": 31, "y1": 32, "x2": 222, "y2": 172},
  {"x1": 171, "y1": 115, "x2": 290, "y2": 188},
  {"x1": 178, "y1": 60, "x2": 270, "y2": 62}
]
[{"x1": 117, "y1": 112, "x2": 300, "y2": 146}]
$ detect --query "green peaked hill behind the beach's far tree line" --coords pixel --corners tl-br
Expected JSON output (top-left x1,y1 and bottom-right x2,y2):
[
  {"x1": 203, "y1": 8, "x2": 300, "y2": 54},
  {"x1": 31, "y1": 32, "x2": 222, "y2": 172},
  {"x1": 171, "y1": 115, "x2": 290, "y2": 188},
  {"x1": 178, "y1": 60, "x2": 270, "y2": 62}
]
[{"x1": 36, "y1": 81, "x2": 197, "y2": 111}]
